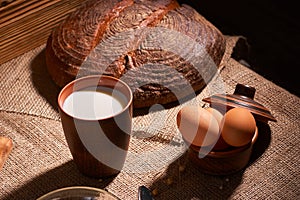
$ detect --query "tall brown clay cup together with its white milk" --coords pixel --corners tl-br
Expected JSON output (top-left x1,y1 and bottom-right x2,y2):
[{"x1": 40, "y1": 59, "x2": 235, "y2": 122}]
[{"x1": 58, "y1": 75, "x2": 133, "y2": 178}]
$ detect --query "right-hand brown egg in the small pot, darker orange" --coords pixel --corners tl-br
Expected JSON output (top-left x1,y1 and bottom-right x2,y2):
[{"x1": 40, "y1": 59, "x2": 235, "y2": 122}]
[{"x1": 221, "y1": 108, "x2": 256, "y2": 147}]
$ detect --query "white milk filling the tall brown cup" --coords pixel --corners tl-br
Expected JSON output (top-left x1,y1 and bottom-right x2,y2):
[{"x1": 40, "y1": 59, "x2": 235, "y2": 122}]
[{"x1": 63, "y1": 87, "x2": 126, "y2": 120}]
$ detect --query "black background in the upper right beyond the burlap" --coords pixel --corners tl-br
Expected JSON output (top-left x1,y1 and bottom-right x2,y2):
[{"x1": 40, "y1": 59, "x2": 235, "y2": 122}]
[{"x1": 179, "y1": 0, "x2": 300, "y2": 96}]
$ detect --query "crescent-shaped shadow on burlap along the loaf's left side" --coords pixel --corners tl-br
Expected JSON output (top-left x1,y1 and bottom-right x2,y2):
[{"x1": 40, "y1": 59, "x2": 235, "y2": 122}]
[{"x1": 31, "y1": 49, "x2": 61, "y2": 111}]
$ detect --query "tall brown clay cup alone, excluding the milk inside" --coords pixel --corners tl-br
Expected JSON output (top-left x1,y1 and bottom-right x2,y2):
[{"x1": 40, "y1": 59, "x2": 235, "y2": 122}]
[{"x1": 58, "y1": 75, "x2": 133, "y2": 178}]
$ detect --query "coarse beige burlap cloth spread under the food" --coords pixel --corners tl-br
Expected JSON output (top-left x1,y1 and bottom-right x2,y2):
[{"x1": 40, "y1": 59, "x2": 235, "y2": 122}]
[{"x1": 0, "y1": 37, "x2": 300, "y2": 199}]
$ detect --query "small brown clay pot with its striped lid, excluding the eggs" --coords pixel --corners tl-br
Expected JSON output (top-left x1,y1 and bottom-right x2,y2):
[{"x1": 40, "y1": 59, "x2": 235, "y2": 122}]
[{"x1": 188, "y1": 84, "x2": 276, "y2": 175}]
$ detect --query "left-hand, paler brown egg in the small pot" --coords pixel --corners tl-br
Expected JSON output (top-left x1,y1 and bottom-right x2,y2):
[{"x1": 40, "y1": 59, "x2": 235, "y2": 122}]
[{"x1": 177, "y1": 106, "x2": 220, "y2": 147}]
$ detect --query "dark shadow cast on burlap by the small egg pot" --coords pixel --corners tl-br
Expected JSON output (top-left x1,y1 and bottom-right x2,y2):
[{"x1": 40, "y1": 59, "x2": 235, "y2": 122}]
[{"x1": 150, "y1": 122, "x2": 271, "y2": 200}]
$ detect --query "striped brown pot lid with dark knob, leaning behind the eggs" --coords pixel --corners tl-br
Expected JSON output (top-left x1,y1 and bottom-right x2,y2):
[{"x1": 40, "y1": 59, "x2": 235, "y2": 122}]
[{"x1": 202, "y1": 83, "x2": 277, "y2": 122}]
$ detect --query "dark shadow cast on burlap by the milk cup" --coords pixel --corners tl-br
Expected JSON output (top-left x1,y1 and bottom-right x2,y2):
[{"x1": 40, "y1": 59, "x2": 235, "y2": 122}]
[{"x1": 3, "y1": 161, "x2": 114, "y2": 199}]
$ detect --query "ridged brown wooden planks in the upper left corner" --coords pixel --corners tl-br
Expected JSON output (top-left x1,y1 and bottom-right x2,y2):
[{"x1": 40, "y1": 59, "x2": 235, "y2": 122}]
[{"x1": 0, "y1": 0, "x2": 85, "y2": 64}]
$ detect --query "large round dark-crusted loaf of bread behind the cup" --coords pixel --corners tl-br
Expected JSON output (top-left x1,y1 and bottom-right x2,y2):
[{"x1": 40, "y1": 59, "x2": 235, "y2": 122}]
[{"x1": 46, "y1": 0, "x2": 225, "y2": 108}]
